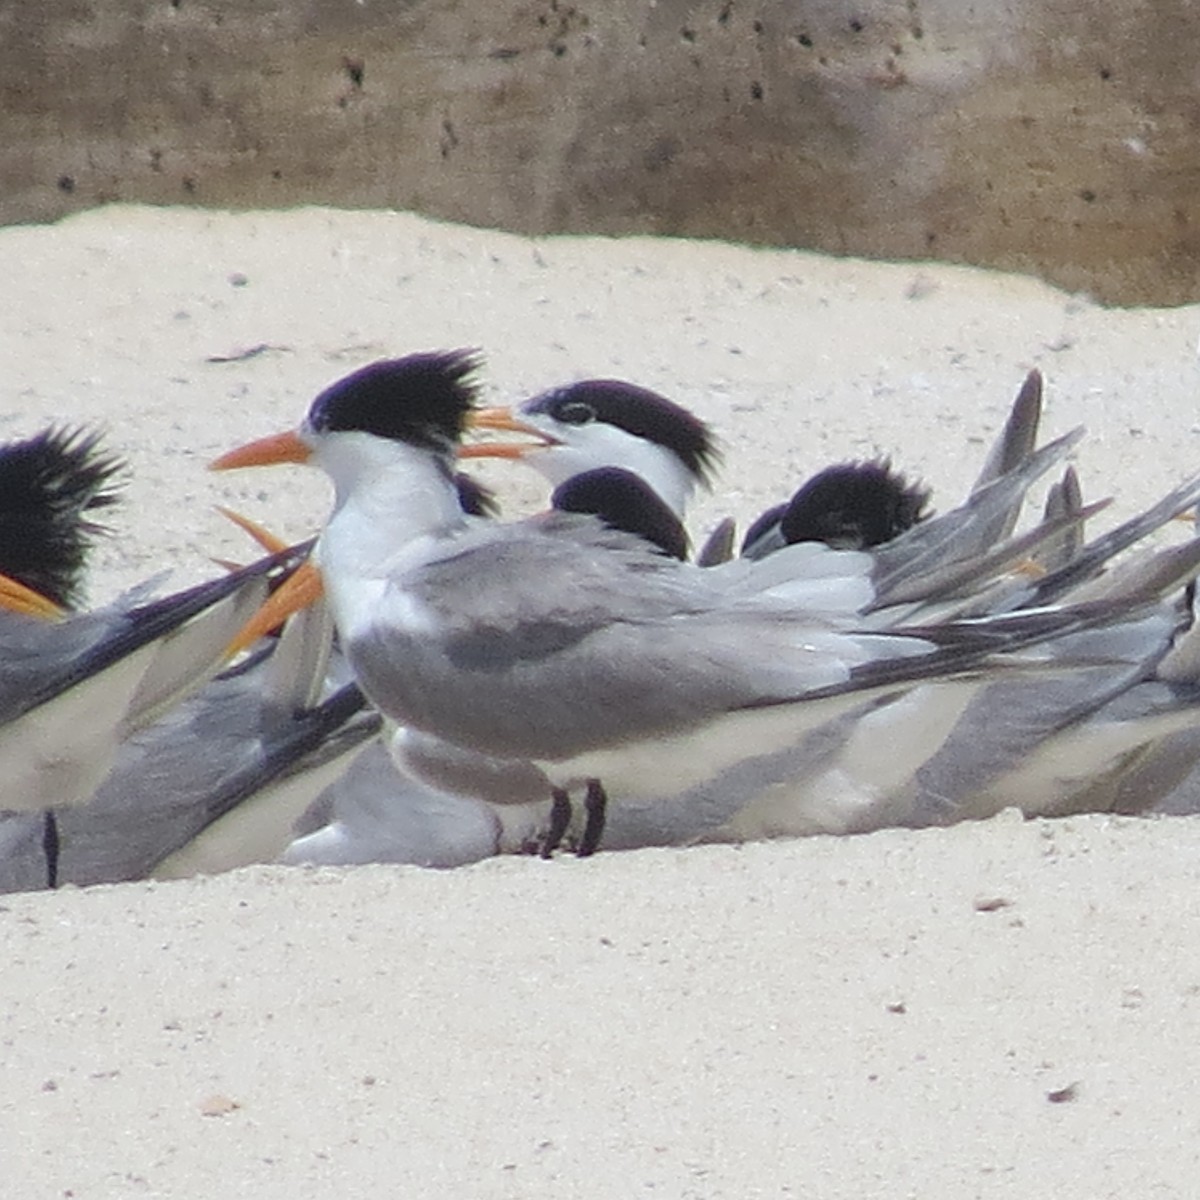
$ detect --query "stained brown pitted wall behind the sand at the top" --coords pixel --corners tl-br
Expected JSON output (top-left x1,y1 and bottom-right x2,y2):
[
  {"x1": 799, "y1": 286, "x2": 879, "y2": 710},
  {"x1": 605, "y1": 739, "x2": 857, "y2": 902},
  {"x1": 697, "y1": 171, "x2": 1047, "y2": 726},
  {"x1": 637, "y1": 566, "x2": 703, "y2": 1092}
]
[{"x1": 7, "y1": 0, "x2": 1200, "y2": 304}]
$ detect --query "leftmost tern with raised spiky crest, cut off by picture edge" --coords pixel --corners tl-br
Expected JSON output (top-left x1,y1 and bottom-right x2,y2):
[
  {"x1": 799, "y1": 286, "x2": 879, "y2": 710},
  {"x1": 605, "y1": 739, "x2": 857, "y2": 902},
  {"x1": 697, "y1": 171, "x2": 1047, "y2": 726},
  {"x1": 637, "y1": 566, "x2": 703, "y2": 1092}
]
[{"x1": 0, "y1": 428, "x2": 300, "y2": 811}]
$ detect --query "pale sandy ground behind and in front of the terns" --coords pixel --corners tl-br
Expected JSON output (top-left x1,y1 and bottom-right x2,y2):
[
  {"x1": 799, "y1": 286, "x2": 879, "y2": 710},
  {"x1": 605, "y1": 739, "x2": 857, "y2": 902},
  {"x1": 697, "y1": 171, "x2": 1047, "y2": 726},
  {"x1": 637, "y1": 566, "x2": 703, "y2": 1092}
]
[{"x1": 0, "y1": 209, "x2": 1200, "y2": 1198}]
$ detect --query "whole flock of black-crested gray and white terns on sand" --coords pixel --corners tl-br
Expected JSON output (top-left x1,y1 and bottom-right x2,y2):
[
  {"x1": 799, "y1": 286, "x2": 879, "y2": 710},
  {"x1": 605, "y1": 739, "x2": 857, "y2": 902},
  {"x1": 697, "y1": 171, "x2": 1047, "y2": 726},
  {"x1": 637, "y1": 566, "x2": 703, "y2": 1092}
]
[{"x1": 0, "y1": 350, "x2": 1200, "y2": 890}]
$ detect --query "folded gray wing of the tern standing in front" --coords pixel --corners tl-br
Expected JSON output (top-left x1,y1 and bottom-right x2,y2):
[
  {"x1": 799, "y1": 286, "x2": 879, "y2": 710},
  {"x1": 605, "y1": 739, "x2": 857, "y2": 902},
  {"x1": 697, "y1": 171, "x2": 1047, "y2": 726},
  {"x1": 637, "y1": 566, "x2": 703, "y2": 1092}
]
[{"x1": 347, "y1": 513, "x2": 1161, "y2": 760}]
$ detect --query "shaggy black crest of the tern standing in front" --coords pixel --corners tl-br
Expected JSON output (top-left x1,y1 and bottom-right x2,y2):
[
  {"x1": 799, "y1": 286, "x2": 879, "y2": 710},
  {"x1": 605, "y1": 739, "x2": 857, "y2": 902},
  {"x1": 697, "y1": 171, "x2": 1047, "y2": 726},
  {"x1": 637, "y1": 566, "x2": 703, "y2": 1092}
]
[{"x1": 308, "y1": 350, "x2": 480, "y2": 451}]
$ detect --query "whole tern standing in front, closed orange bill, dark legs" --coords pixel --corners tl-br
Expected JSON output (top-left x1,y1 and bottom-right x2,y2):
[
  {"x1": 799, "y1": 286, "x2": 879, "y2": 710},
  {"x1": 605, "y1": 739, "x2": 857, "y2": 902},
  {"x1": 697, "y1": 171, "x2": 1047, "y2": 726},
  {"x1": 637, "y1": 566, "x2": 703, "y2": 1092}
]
[{"x1": 215, "y1": 352, "x2": 1161, "y2": 853}]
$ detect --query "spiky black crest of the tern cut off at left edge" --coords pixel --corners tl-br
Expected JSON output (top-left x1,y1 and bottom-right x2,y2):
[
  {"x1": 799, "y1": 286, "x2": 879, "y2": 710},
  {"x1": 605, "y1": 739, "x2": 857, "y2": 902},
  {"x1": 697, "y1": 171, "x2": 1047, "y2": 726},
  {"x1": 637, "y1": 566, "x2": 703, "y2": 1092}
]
[{"x1": 0, "y1": 428, "x2": 125, "y2": 608}]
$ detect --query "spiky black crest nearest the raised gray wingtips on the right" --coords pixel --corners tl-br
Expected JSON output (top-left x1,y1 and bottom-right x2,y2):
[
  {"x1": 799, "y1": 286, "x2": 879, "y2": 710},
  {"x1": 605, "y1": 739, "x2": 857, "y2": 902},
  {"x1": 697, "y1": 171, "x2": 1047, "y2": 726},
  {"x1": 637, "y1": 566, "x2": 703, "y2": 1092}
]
[{"x1": 780, "y1": 460, "x2": 930, "y2": 550}]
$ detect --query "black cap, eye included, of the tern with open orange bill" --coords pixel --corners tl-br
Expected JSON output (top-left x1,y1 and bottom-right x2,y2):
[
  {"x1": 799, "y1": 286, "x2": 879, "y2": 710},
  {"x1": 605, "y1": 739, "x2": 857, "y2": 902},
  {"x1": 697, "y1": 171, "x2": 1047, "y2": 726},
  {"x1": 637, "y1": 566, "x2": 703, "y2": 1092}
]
[{"x1": 523, "y1": 379, "x2": 720, "y2": 482}]
